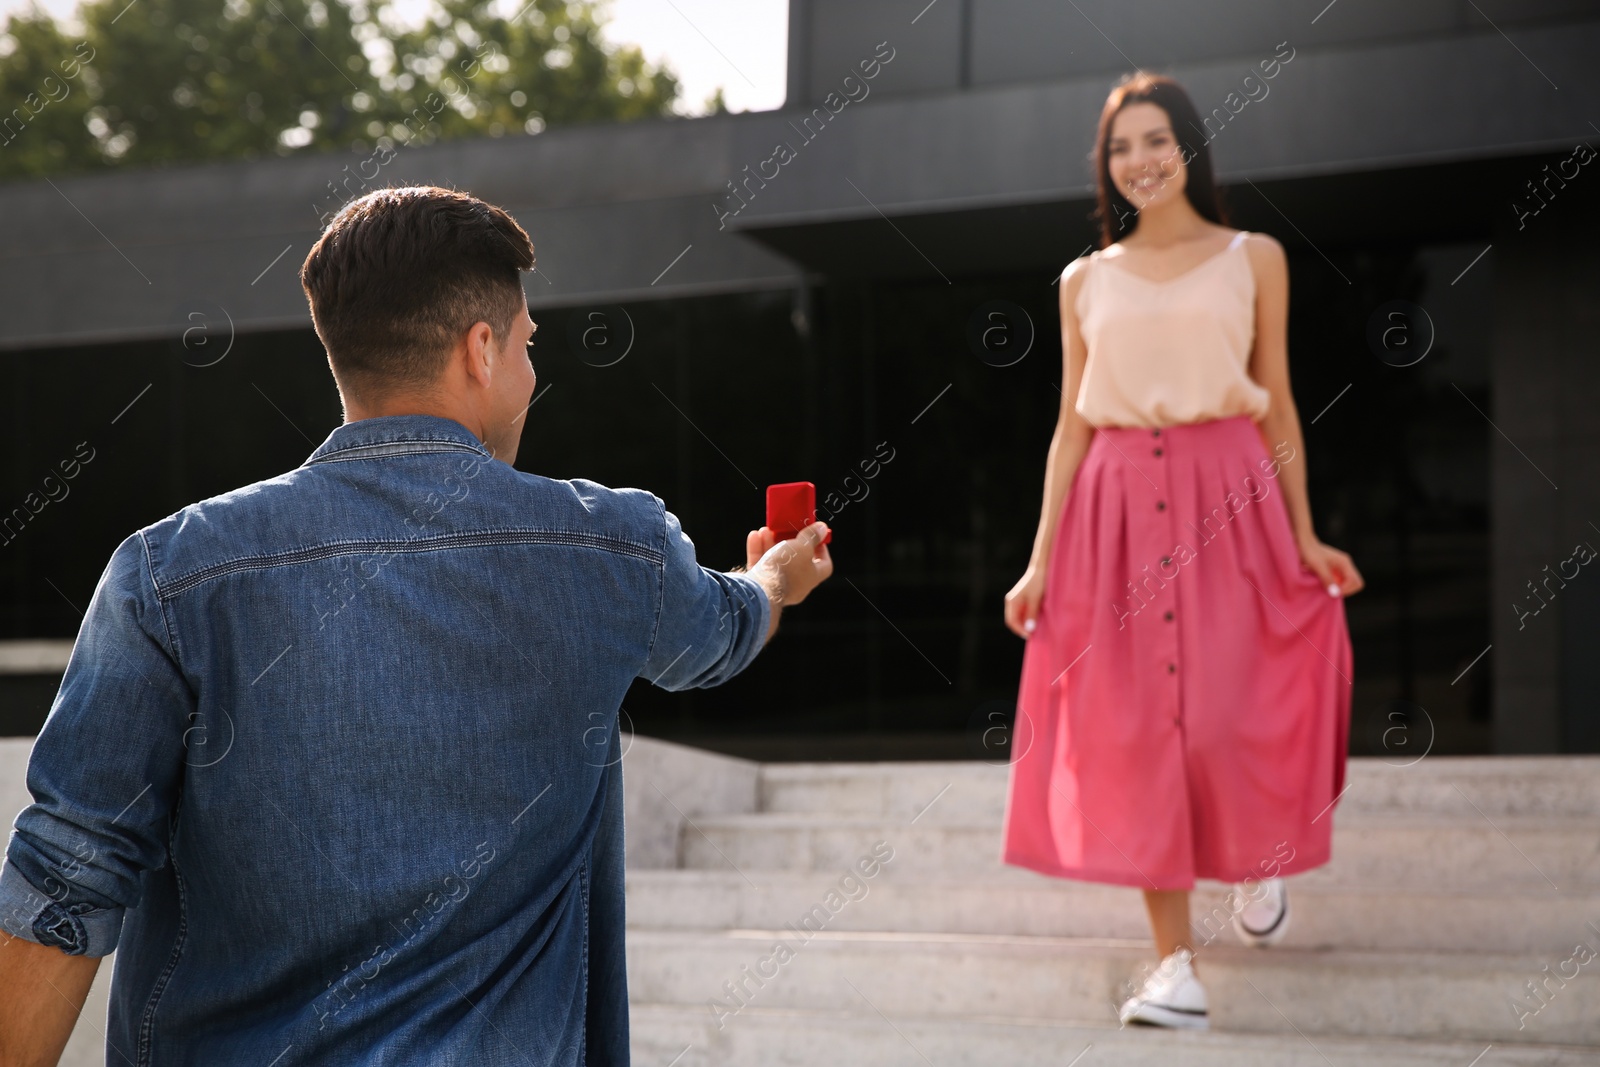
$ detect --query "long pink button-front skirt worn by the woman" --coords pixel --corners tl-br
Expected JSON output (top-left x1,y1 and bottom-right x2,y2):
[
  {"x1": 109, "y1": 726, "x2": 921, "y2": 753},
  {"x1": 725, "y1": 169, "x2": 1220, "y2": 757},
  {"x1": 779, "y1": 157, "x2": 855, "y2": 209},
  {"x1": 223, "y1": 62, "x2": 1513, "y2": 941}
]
[{"x1": 1002, "y1": 416, "x2": 1354, "y2": 889}]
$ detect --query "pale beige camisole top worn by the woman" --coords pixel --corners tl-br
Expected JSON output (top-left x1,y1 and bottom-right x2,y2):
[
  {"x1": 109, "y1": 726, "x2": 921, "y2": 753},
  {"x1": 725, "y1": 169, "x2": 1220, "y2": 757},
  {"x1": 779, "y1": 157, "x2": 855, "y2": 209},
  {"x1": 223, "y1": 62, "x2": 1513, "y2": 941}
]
[{"x1": 1074, "y1": 230, "x2": 1272, "y2": 427}]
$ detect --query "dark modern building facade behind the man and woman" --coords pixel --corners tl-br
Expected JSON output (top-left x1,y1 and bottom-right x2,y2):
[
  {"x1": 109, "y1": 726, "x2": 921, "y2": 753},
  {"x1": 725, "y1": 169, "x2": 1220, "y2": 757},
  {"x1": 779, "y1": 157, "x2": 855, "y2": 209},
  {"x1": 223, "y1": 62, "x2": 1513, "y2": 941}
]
[{"x1": 0, "y1": 0, "x2": 1600, "y2": 758}]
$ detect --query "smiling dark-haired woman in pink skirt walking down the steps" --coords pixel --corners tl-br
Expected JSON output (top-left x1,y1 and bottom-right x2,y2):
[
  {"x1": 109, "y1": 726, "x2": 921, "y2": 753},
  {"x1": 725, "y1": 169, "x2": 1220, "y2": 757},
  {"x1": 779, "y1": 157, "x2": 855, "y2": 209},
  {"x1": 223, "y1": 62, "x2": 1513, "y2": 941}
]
[{"x1": 1002, "y1": 74, "x2": 1362, "y2": 1029}]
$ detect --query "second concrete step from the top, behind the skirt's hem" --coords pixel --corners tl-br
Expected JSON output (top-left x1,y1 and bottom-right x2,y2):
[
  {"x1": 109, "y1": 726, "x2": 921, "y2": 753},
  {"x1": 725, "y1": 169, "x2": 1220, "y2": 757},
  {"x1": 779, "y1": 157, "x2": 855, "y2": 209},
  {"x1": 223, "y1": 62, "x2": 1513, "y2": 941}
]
[{"x1": 680, "y1": 813, "x2": 1600, "y2": 894}]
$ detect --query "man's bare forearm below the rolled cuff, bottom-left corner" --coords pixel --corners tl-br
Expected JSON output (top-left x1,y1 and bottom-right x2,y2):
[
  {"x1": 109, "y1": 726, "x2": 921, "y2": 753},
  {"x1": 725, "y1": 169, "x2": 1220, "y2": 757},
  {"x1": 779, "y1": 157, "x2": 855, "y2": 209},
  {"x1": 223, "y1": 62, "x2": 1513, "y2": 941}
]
[{"x1": 0, "y1": 931, "x2": 102, "y2": 1067}]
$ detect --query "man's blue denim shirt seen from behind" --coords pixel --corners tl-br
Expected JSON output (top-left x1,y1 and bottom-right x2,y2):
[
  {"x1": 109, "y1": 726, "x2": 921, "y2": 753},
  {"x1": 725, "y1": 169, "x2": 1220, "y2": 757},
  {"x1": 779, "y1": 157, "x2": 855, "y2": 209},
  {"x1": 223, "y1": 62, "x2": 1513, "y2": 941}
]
[{"x1": 0, "y1": 414, "x2": 771, "y2": 1067}]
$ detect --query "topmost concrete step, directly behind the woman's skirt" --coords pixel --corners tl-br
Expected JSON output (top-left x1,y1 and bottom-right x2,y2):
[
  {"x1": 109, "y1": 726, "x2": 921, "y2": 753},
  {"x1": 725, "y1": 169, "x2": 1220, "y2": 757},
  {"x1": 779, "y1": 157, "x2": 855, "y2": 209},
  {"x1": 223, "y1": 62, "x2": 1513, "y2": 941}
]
[{"x1": 758, "y1": 755, "x2": 1600, "y2": 822}]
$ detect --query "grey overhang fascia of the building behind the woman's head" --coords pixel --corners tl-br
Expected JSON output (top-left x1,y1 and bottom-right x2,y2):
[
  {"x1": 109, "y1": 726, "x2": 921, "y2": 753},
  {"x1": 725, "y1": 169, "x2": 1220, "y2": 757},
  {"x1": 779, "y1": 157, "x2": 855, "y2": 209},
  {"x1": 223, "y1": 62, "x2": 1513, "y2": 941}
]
[{"x1": 734, "y1": 22, "x2": 1600, "y2": 227}]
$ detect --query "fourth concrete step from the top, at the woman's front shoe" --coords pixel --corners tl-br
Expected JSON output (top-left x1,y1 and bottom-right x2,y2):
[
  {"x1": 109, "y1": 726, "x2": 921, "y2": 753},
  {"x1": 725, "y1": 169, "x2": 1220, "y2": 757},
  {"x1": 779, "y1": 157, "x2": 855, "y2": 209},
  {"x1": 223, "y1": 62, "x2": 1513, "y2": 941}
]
[{"x1": 627, "y1": 928, "x2": 1600, "y2": 1062}]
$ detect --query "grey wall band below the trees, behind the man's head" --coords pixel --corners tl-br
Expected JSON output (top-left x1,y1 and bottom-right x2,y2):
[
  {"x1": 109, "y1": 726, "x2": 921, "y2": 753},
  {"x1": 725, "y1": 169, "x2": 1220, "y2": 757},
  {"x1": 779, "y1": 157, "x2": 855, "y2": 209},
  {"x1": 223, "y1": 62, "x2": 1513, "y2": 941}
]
[{"x1": 0, "y1": 117, "x2": 794, "y2": 349}]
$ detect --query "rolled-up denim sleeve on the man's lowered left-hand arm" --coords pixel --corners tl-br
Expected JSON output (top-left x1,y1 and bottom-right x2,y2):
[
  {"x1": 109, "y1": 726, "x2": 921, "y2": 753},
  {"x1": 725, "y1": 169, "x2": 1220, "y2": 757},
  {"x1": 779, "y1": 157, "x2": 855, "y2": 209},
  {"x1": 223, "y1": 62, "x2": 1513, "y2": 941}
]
[{"x1": 0, "y1": 534, "x2": 195, "y2": 957}]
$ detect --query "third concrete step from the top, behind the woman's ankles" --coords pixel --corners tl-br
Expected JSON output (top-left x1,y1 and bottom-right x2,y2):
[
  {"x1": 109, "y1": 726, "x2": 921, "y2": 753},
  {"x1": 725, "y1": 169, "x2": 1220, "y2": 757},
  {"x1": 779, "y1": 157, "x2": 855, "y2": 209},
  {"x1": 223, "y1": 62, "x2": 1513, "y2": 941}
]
[{"x1": 627, "y1": 861, "x2": 1600, "y2": 961}]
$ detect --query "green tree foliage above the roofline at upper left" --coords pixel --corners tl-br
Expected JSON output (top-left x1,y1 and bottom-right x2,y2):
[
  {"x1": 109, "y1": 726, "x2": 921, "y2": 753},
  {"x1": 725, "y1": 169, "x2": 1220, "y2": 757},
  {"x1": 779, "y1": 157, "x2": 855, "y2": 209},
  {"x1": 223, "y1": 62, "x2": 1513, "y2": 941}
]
[{"x1": 0, "y1": 0, "x2": 678, "y2": 178}]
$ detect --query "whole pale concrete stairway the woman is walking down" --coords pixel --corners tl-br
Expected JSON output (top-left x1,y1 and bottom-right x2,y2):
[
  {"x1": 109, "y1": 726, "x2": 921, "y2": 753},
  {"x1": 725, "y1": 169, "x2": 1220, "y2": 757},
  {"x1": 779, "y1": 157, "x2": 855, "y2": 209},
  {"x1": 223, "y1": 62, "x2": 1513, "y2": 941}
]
[{"x1": 624, "y1": 737, "x2": 1600, "y2": 1067}]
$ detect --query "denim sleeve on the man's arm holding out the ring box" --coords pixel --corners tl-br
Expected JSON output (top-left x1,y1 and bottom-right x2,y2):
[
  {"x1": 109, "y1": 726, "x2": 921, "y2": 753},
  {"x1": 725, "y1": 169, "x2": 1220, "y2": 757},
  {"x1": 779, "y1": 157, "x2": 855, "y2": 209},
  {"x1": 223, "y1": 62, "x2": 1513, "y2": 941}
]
[{"x1": 640, "y1": 498, "x2": 773, "y2": 689}]
